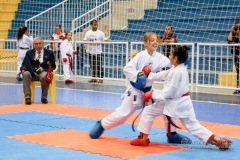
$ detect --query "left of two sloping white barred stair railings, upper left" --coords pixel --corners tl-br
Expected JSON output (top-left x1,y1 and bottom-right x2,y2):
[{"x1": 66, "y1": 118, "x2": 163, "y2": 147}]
[{"x1": 25, "y1": 0, "x2": 107, "y2": 40}]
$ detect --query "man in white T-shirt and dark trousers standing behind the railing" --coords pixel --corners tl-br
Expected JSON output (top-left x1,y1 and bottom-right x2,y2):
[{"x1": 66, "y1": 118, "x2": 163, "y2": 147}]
[{"x1": 83, "y1": 20, "x2": 107, "y2": 83}]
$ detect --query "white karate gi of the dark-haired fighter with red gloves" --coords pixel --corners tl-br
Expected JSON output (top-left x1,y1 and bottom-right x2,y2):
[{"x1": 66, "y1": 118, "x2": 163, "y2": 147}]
[{"x1": 138, "y1": 63, "x2": 213, "y2": 143}]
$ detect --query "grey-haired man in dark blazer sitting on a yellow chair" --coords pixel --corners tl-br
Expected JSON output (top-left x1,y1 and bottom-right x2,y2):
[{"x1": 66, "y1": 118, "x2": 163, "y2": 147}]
[{"x1": 21, "y1": 37, "x2": 56, "y2": 105}]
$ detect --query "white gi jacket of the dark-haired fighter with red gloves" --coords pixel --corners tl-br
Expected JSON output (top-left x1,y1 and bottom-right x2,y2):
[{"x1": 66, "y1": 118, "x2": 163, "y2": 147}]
[{"x1": 152, "y1": 63, "x2": 195, "y2": 118}]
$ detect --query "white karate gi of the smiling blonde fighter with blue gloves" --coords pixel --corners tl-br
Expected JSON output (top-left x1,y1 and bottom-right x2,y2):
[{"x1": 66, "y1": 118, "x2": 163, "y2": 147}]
[{"x1": 101, "y1": 50, "x2": 175, "y2": 131}]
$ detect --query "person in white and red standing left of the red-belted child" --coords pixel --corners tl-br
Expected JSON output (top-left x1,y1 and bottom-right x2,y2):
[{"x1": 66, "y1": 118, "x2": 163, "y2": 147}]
[{"x1": 50, "y1": 25, "x2": 65, "y2": 60}]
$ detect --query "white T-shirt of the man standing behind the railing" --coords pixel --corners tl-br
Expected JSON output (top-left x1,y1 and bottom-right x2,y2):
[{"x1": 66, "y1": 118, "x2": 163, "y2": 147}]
[{"x1": 83, "y1": 30, "x2": 107, "y2": 54}]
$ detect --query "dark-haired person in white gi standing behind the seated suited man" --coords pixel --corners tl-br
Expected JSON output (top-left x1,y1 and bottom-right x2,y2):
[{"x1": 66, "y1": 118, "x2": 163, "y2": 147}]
[{"x1": 16, "y1": 26, "x2": 33, "y2": 81}]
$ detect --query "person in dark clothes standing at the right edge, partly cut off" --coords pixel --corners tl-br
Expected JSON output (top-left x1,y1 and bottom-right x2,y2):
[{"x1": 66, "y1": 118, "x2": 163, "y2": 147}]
[{"x1": 228, "y1": 20, "x2": 240, "y2": 94}]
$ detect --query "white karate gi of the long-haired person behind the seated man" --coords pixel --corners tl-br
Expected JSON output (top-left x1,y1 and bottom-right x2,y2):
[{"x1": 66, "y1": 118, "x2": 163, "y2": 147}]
[{"x1": 17, "y1": 34, "x2": 33, "y2": 73}]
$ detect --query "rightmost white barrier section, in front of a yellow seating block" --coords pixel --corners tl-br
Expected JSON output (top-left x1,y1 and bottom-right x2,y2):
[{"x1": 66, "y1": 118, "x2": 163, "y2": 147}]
[{"x1": 195, "y1": 43, "x2": 240, "y2": 89}]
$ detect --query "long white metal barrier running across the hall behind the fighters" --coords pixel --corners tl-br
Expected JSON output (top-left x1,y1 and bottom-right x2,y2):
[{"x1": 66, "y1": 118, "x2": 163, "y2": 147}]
[{"x1": 0, "y1": 39, "x2": 240, "y2": 91}]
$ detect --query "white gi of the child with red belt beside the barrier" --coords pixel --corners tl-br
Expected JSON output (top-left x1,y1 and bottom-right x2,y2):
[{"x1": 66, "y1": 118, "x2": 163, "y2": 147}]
[{"x1": 60, "y1": 39, "x2": 73, "y2": 80}]
